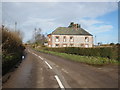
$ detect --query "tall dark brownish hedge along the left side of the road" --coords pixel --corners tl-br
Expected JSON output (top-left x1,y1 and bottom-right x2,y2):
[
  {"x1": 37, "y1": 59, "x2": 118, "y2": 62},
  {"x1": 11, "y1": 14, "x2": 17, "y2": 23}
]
[{"x1": 0, "y1": 28, "x2": 25, "y2": 75}]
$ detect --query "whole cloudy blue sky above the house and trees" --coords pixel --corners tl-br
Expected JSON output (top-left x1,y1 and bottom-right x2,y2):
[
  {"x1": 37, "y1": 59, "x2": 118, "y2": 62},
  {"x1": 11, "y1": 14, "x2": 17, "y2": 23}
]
[{"x1": 2, "y1": 2, "x2": 118, "y2": 44}]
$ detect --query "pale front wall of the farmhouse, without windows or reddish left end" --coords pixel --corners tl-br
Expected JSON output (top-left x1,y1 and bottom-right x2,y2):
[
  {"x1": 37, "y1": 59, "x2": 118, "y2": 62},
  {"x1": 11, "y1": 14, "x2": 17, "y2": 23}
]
[{"x1": 48, "y1": 35, "x2": 93, "y2": 47}]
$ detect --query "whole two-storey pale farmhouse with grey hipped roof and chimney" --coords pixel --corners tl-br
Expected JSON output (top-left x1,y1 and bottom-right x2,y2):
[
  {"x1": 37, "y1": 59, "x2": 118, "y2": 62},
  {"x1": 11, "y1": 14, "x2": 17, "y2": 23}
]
[{"x1": 47, "y1": 22, "x2": 93, "y2": 48}]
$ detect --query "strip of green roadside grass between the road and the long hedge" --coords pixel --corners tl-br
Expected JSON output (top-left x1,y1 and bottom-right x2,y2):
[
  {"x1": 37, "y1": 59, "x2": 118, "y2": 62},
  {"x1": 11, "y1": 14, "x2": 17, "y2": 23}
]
[{"x1": 35, "y1": 49, "x2": 120, "y2": 66}]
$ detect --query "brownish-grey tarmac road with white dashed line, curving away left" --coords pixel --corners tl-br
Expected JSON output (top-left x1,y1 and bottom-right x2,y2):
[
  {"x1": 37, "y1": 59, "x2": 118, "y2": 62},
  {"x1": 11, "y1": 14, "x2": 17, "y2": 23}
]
[{"x1": 3, "y1": 48, "x2": 118, "y2": 90}]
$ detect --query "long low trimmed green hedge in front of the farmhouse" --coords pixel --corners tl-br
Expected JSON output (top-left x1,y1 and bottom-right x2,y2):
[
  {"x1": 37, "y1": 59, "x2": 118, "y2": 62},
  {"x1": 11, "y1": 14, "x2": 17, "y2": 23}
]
[{"x1": 44, "y1": 46, "x2": 119, "y2": 60}]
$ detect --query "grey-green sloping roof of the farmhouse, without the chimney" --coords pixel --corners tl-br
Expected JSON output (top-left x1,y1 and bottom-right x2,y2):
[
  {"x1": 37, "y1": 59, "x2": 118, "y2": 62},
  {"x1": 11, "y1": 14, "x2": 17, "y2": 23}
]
[{"x1": 51, "y1": 27, "x2": 92, "y2": 36}]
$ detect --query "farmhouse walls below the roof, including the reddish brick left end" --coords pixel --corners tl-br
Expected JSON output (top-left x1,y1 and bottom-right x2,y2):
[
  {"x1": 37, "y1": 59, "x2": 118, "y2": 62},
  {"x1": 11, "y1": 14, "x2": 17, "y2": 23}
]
[{"x1": 48, "y1": 35, "x2": 93, "y2": 47}]
